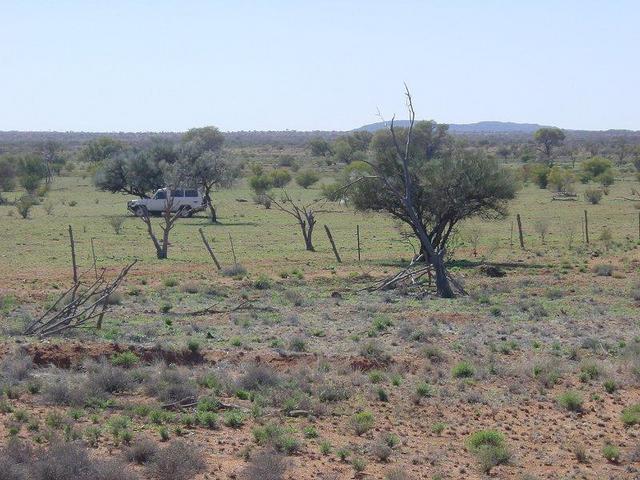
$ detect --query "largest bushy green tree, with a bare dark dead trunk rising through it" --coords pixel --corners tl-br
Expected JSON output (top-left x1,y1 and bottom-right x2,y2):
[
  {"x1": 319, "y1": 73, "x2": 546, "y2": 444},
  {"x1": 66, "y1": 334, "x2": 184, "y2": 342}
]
[{"x1": 340, "y1": 95, "x2": 516, "y2": 297}]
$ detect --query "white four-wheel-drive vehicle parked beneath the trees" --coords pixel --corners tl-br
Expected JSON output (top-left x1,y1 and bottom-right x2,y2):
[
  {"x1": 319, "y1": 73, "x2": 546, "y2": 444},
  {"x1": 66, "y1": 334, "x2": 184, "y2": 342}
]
[{"x1": 127, "y1": 188, "x2": 207, "y2": 217}]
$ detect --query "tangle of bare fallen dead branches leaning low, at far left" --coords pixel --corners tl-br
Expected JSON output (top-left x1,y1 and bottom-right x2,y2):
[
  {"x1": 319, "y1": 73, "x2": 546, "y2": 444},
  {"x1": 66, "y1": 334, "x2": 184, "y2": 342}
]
[{"x1": 24, "y1": 260, "x2": 137, "y2": 337}]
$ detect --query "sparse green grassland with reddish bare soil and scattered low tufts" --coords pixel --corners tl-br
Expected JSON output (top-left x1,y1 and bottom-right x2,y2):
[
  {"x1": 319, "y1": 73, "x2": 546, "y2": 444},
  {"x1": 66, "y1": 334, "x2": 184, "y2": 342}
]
[{"x1": 0, "y1": 171, "x2": 640, "y2": 480}]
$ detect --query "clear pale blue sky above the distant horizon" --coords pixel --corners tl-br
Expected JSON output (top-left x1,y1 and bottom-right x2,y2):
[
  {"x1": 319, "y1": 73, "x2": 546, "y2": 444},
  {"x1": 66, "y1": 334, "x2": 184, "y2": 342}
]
[{"x1": 0, "y1": 0, "x2": 640, "y2": 131}]
